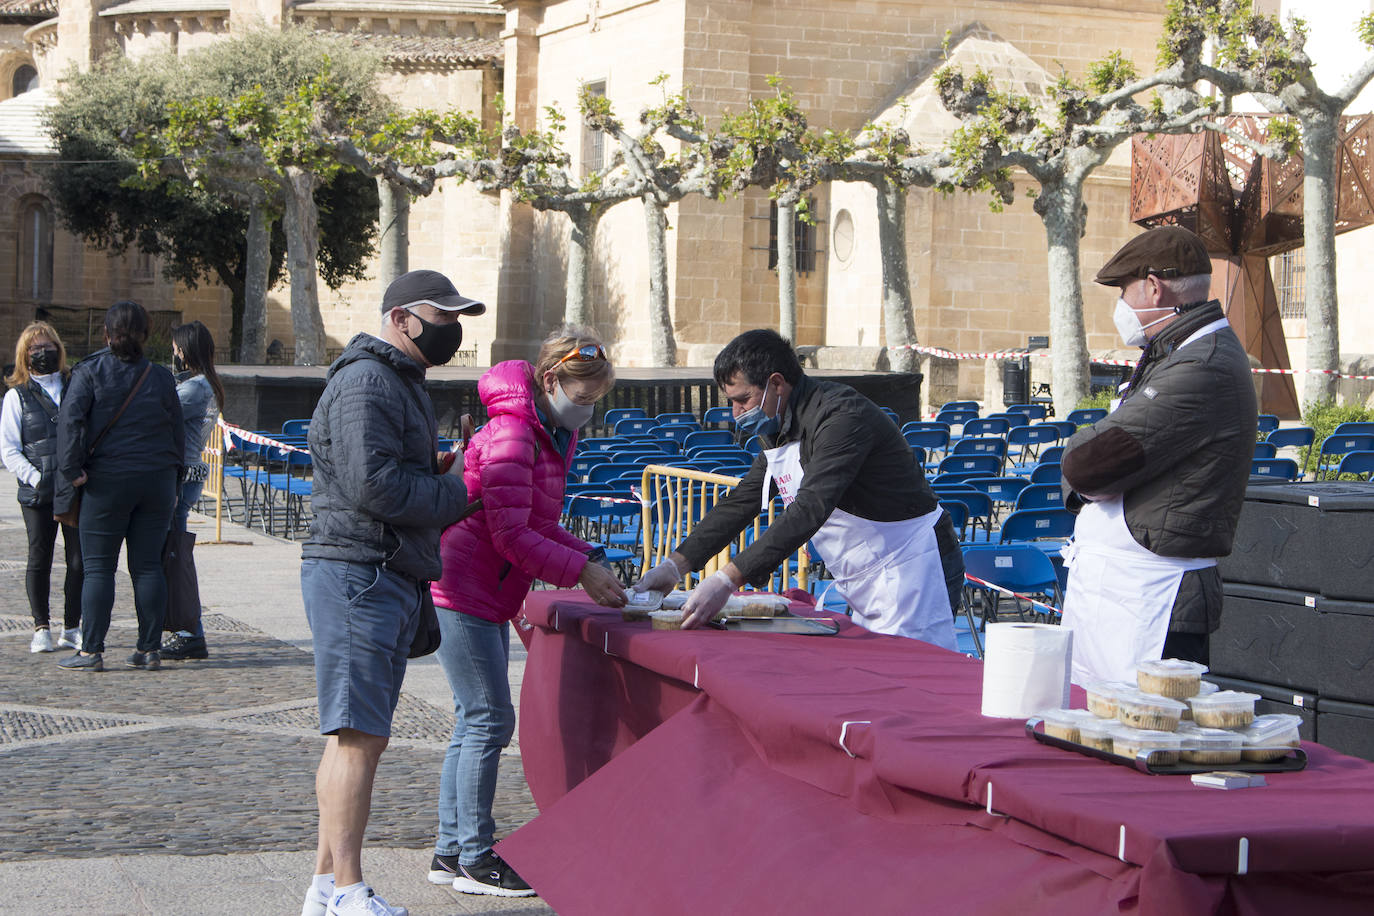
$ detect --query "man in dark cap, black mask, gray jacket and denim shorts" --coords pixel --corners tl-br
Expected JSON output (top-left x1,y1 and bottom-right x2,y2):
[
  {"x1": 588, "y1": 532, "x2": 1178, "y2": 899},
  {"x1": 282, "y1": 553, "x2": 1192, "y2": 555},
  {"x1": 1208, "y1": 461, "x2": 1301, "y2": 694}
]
[{"x1": 301, "y1": 271, "x2": 486, "y2": 916}]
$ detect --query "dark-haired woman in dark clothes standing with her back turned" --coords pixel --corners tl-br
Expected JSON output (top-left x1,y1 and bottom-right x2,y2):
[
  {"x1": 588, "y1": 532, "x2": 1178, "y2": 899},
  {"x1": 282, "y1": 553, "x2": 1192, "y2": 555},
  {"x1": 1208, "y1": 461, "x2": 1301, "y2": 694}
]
[{"x1": 54, "y1": 299, "x2": 184, "y2": 672}]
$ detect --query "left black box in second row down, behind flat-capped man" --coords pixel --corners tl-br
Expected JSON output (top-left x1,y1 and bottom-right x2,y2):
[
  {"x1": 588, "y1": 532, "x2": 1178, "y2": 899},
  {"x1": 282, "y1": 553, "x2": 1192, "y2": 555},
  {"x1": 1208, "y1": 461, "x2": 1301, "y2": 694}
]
[{"x1": 1209, "y1": 582, "x2": 1325, "y2": 692}]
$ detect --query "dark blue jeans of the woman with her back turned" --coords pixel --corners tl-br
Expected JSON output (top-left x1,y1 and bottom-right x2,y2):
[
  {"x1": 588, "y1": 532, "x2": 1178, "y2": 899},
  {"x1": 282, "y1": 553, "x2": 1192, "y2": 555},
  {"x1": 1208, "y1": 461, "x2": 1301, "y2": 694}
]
[{"x1": 77, "y1": 468, "x2": 176, "y2": 652}]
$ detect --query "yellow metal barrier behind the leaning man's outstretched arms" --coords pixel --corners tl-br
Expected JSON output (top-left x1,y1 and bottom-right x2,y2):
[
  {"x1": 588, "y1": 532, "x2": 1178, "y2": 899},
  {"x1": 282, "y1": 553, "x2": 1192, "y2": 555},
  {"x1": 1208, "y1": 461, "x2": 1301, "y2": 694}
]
[{"x1": 640, "y1": 464, "x2": 809, "y2": 592}]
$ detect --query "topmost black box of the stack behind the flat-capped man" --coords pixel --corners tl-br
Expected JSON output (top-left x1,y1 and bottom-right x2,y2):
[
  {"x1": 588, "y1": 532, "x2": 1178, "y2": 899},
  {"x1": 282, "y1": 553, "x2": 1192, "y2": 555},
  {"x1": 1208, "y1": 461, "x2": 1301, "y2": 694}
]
[{"x1": 1217, "y1": 481, "x2": 1374, "y2": 599}]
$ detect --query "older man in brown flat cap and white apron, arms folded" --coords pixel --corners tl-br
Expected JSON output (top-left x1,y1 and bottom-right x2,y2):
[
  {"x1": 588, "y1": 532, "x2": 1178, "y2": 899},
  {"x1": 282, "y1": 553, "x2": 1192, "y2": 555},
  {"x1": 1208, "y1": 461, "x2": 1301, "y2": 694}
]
[{"x1": 1063, "y1": 227, "x2": 1256, "y2": 684}]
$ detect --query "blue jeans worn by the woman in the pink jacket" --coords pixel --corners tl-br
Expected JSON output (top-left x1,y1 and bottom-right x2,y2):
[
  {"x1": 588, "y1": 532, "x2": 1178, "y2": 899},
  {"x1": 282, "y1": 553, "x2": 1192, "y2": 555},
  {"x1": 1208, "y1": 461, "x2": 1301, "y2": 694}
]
[{"x1": 434, "y1": 607, "x2": 515, "y2": 865}]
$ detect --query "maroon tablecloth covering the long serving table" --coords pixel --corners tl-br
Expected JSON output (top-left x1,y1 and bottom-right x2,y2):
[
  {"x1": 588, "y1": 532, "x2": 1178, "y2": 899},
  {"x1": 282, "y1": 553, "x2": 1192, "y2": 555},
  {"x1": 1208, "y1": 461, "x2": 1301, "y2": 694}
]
[{"x1": 500, "y1": 592, "x2": 1374, "y2": 916}]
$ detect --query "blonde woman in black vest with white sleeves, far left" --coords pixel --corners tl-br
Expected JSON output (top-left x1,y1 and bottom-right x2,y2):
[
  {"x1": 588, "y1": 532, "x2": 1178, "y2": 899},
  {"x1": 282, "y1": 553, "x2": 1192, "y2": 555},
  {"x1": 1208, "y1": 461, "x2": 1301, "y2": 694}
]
[{"x1": 0, "y1": 321, "x2": 84, "y2": 652}]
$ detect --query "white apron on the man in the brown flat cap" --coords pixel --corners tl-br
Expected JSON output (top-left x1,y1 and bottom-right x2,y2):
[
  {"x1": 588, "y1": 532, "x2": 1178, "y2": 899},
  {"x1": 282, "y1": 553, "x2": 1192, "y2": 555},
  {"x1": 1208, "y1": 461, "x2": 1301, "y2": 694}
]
[{"x1": 1062, "y1": 319, "x2": 1227, "y2": 687}]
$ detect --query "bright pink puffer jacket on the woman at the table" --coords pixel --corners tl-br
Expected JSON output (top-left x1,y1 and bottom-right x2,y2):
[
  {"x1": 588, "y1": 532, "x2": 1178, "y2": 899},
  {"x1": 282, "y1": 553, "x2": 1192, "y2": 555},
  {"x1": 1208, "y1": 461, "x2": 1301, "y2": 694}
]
[{"x1": 434, "y1": 360, "x2": 591, "y2": 622}]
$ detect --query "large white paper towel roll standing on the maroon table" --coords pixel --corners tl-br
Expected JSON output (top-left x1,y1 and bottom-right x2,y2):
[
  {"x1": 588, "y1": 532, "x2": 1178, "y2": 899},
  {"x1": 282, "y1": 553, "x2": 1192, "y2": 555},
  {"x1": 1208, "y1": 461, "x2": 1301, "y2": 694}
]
[{"x1": 982, "y1": 623, "x2": 1073, "y2": 718}]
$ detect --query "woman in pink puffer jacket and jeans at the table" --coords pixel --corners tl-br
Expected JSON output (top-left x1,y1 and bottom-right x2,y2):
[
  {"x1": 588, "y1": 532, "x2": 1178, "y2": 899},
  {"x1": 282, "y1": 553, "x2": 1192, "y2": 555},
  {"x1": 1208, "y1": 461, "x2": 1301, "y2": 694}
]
[{"x1": 429, "y1": 328, "x2": 625, "y2": 897}]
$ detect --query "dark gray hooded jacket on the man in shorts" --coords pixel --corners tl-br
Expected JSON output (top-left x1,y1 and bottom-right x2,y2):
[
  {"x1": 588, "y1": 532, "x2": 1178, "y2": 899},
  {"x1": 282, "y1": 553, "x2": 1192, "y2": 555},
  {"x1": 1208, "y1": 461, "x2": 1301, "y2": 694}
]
[{"x1": 301, "y1": 334, "x2": 467, "y2": 581}]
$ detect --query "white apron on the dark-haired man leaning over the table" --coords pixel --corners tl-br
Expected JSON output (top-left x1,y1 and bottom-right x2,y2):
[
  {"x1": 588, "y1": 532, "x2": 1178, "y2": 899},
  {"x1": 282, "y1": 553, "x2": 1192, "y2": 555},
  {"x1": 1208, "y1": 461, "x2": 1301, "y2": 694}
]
[{"x1": 763, "y1": 442, "x2": 956, "y2": 650}]
